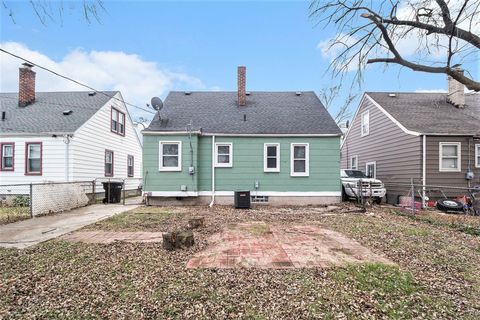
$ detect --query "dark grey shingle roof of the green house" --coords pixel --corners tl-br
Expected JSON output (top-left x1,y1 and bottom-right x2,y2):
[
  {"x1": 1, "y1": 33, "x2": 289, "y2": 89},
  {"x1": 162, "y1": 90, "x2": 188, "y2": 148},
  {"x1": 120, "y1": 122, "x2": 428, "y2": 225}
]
[{"x1": 146, "y1": 91, "x2": 341, "y2": 134}]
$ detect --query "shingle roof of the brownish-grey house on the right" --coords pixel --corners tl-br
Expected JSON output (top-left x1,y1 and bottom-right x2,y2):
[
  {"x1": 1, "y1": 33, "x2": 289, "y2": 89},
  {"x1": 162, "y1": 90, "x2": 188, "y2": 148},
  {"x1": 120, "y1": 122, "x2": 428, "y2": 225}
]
[{"x1": 367, "y1": 92, "x2": 480, "y2": 135}]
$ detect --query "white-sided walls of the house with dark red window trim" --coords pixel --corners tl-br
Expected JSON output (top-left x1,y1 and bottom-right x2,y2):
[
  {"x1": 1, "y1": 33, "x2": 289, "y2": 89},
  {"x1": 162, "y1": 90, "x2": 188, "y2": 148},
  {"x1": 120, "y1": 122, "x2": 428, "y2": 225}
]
[{"x1": 0, "y1": 92, "x2": 142, "y2": 189}]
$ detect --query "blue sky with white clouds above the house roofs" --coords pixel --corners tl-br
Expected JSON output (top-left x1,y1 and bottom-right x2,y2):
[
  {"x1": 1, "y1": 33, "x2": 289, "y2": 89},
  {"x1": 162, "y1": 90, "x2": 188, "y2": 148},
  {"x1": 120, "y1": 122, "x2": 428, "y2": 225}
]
[{"x1": 0, "y1": 1, "x2": 478, "y2": 118}]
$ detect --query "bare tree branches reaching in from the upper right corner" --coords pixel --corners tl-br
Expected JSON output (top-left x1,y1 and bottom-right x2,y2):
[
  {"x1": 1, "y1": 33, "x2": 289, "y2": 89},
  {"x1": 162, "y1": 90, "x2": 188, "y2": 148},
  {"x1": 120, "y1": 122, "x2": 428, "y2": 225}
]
[{"x1": 310, "y1": 0, "x2": 480, "y2": 91}]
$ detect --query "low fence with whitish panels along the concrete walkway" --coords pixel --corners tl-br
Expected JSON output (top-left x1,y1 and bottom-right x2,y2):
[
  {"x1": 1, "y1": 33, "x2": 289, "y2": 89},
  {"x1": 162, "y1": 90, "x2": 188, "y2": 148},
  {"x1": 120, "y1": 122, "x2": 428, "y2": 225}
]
[{"x1": 0, "y1": 178, "x2": 141, "y2": 222}]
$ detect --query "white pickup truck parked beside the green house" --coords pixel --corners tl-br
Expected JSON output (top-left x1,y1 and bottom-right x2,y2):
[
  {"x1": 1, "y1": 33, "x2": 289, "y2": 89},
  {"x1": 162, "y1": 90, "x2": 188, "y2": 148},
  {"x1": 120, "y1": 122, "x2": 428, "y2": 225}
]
[{"x1": 340, "y1": 169, "x2": 387, "y2": 203}]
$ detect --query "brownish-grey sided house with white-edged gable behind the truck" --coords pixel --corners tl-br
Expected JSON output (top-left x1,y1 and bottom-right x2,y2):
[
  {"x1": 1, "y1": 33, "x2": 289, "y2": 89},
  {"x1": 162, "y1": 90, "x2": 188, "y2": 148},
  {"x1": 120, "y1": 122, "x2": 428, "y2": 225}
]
[{"x1": 341, "y1": 76, "x2": 480, "y2": 203}]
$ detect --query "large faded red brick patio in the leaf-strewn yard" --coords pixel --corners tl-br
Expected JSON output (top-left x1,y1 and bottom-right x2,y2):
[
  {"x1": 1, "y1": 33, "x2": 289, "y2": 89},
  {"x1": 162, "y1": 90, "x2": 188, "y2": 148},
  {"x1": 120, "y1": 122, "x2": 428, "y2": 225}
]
[{"x1": 187, "y1": 222, "x2": 391, "y2": 269}]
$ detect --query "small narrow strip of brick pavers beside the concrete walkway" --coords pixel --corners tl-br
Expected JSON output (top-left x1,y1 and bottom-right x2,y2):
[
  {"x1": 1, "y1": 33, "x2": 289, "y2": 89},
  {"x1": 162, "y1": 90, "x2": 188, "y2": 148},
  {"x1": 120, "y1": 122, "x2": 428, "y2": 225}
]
[{"x1": 61, "y1": 231, "x2": 162, "y2": 243}]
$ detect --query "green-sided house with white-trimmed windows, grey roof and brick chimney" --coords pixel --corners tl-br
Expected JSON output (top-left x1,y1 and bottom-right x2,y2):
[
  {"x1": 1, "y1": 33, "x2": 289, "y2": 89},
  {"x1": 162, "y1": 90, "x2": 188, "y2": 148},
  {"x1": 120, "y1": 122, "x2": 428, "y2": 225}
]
[{"x1": 143, "y1": 67, "x2": 341, "y2": 205}]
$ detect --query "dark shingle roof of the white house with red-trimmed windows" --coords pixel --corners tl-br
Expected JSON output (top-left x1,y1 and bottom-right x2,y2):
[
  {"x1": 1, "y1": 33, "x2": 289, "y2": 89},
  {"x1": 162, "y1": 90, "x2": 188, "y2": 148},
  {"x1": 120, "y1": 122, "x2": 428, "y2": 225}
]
[{"x1": 0, "y1": 91, "x2": 117, "y2": 134}]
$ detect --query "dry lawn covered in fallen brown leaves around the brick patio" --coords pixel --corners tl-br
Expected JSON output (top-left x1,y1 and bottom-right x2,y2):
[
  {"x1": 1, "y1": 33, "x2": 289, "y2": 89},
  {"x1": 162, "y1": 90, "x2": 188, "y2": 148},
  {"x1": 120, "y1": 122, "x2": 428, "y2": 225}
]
[{"x1": 0, "y1": 206, "x2": 480, "y2": 319}]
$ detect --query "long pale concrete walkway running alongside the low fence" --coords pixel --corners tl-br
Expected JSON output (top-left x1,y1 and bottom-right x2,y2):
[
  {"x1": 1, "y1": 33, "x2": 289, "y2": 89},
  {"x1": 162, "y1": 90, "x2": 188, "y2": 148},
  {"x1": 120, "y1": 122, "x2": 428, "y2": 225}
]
[{"x1": 0, "y1": 197, "x2": 141, "y2": 249}]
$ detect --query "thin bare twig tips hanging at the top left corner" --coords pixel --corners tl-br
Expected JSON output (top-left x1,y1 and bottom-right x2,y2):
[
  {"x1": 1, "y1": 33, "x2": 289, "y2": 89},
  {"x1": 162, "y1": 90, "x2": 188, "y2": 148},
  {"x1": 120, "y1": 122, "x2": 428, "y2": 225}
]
[{"x1": 2, "y1": 0, "x2": 106, "y2": 25}]
